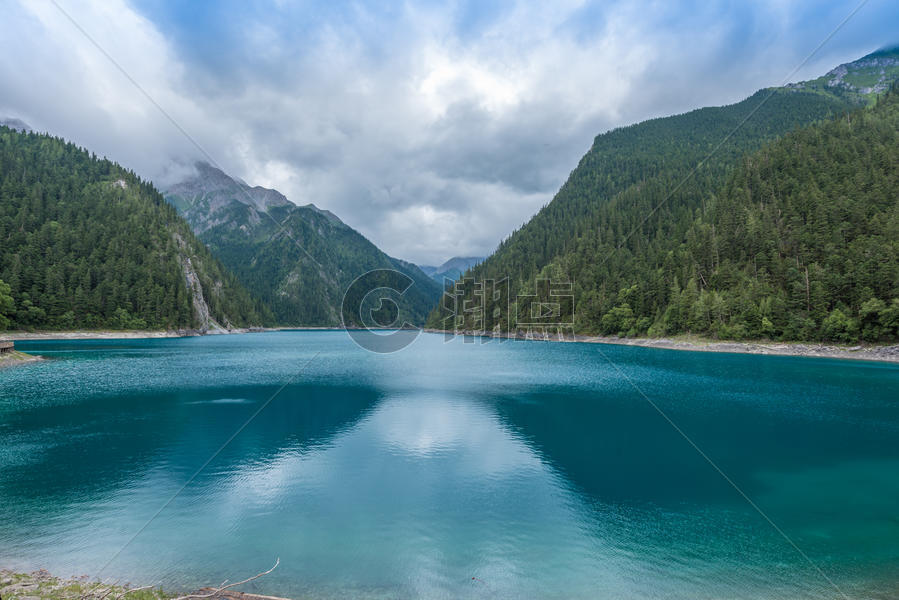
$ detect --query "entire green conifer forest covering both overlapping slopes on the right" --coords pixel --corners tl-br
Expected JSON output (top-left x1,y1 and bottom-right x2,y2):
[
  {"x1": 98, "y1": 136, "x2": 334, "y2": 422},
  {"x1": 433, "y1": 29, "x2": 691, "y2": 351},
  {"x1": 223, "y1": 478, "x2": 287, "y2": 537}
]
[{"x1": 429, "y1": 50, "x2": 899, "y2": 341}]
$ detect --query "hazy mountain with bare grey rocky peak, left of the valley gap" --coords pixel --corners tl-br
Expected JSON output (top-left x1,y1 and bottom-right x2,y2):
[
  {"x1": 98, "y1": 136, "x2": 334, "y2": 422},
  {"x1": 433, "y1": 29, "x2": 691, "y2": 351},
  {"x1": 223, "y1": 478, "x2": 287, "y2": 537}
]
[{"x1": 165, "y1": 163, "x2": 440, "y2": 326}]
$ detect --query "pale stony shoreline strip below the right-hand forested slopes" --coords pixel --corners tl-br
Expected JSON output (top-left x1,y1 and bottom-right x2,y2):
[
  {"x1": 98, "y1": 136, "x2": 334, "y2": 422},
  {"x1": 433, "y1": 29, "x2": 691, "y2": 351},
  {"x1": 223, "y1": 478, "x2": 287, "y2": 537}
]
[{"x1": 423, "y1": 329, "x2": 899, "y2": 363}]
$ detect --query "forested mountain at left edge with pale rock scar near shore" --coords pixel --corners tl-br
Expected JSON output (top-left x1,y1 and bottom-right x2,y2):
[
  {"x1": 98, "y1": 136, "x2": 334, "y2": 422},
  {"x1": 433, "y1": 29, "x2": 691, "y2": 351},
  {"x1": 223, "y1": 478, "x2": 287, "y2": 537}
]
[{"x1": 0, "y1": 126, "x2": 264, "y2": 330}]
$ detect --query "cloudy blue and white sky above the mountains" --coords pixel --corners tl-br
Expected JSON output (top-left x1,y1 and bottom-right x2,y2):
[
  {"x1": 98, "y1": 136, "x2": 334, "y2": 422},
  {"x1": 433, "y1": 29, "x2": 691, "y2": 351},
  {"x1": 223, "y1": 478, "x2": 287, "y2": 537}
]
[{"x1": 0, "y1": 0, "x2": 899, "y2": 264}]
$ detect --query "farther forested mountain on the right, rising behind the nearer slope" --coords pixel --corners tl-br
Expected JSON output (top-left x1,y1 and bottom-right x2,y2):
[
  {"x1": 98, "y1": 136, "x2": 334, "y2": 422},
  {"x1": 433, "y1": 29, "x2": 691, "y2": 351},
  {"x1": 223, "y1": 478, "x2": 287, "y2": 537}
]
[{"x1": 429, "y1": 49, "x2": 899, "y2": 339}]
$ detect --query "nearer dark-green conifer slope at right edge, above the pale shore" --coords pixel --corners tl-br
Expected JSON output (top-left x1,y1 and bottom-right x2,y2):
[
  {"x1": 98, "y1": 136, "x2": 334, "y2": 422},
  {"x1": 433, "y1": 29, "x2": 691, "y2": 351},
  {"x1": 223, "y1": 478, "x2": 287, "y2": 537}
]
[{"x1": 656, "y1": 91, "x2": 899, "y2": 342}]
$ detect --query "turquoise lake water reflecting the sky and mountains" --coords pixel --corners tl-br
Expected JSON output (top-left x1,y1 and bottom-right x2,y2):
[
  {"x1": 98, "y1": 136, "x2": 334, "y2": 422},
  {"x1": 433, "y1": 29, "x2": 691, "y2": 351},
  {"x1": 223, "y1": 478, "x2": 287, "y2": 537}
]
[{"x1": 0, "y1": 332, "x2": 899, "y2": 599}]
